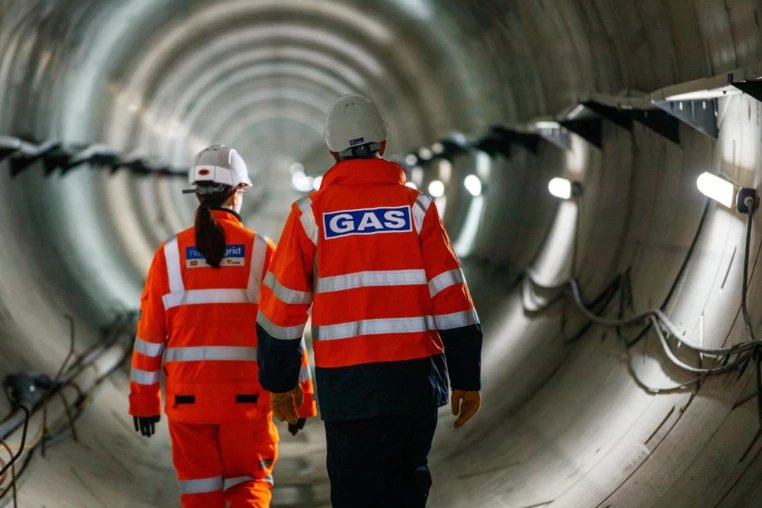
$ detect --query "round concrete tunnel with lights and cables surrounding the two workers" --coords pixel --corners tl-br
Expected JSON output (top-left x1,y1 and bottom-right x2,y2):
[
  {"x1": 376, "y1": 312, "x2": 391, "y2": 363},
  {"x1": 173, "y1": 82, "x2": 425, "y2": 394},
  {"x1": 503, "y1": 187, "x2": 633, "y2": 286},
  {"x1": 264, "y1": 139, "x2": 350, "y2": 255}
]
[{"x1": 0, "y1": 0, "x2": 762, "y2": 508}]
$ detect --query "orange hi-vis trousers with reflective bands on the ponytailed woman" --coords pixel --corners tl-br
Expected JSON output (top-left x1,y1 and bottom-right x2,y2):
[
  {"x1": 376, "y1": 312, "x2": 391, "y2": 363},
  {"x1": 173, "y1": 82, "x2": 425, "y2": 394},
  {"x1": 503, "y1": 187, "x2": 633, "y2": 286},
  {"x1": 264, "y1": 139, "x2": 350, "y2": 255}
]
[{"x1": 169, "y1": 420, "x2": 278, "y2": 508}]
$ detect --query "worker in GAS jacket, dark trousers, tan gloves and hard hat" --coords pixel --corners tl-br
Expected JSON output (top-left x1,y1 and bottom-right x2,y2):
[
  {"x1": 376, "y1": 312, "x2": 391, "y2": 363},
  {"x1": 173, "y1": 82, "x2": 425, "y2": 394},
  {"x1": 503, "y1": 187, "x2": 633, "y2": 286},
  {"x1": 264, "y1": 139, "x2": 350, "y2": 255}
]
[{"x1": 257, "y1": 95, "x2": 482, "y2": 508}]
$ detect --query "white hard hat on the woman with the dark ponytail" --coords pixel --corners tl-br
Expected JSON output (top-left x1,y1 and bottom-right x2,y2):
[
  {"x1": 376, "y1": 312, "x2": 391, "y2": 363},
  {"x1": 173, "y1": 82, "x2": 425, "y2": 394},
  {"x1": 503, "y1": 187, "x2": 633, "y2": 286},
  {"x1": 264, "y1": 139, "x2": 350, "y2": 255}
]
[{"x1": 186, "y1": 145, "x2": 252, "y2": 192}]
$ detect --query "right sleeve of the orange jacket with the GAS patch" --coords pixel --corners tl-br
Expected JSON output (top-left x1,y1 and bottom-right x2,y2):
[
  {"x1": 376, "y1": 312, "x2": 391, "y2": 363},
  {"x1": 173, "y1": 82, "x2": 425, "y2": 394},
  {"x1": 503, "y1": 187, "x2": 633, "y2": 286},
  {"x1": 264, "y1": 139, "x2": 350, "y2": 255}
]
[{"x1": 416, "y1": 198, "x2": 482, "y2": 391}]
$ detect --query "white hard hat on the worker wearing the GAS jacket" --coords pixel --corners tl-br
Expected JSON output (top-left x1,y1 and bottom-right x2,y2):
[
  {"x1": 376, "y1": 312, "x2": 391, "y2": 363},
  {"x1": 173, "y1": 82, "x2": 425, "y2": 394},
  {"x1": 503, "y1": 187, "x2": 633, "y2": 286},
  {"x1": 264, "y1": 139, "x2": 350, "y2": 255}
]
[{"x1": 325, "y1": 94, "x2": 386, "y2": 153}]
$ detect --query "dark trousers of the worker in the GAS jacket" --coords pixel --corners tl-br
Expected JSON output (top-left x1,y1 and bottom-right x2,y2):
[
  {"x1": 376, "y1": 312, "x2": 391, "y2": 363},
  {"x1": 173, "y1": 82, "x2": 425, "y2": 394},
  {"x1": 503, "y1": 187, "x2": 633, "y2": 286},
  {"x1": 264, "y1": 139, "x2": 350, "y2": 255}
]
[{"x1": 325, "y1": 411, "x2": 437, "y2": 508}]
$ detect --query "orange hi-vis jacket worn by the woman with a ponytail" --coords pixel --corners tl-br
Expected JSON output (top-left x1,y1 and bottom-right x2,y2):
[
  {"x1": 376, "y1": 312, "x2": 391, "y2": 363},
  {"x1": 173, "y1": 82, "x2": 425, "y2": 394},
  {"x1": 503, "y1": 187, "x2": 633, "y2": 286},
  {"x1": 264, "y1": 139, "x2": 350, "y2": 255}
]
[{"x1": 130, "y1": 210, "x2": 316, "y2": 424}]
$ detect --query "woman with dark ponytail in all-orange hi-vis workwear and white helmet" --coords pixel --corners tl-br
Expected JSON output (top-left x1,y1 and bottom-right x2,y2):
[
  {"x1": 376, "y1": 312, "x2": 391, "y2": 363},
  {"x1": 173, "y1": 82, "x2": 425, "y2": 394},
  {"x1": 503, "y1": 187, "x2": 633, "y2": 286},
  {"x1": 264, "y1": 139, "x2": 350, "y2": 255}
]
[{"x1": 129, "y1": 145, "x2": 316, "y2": 508}]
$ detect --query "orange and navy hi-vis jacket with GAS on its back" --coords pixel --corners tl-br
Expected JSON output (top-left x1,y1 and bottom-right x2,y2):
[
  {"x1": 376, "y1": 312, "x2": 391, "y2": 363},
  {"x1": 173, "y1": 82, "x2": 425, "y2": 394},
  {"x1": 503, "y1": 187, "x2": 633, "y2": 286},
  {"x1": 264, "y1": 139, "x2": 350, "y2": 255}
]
[{"x1": 257, "y1": 159, "x2": 482, "y2": 421}]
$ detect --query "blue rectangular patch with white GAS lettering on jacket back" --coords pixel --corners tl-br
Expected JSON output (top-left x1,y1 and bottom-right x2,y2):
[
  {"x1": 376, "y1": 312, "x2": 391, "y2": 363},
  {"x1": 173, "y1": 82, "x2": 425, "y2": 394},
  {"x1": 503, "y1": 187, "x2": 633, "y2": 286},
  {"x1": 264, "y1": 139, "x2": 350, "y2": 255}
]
[{"x1": 323, "y1": 206, "x2": 413, "y2": 240}]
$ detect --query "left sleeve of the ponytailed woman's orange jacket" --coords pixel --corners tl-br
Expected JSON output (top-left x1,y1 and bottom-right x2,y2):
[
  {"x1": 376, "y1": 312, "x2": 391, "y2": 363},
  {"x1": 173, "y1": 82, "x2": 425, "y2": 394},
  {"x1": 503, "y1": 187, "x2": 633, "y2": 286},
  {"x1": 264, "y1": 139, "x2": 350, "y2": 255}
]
[{"x1": 129, "y1": 245, "x2": 167, "y2": 417}]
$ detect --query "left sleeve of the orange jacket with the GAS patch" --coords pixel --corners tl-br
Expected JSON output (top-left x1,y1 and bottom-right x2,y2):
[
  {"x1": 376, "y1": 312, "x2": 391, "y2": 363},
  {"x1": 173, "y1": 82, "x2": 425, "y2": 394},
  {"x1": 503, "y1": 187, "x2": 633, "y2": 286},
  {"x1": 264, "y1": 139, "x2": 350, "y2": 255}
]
[{"x1": 257, "y1": 204, "x2": 316, "y2": 396}]
